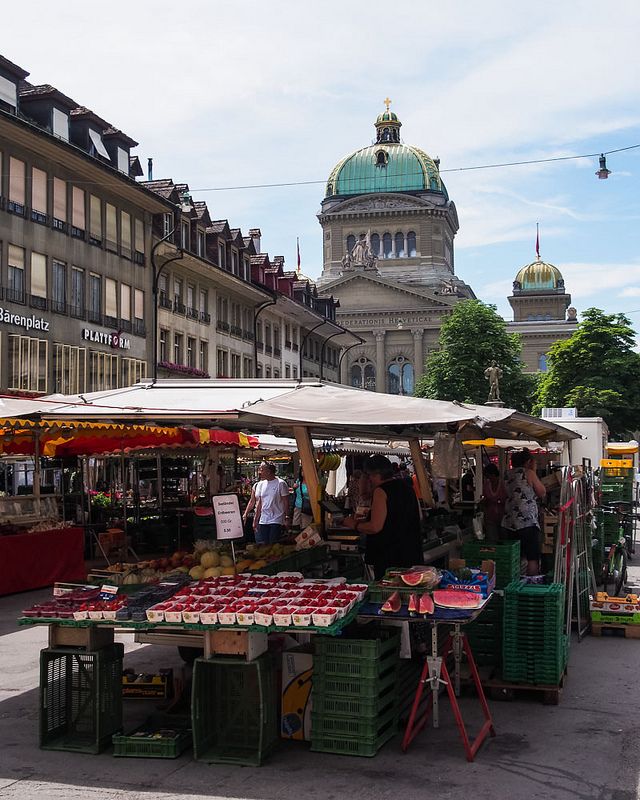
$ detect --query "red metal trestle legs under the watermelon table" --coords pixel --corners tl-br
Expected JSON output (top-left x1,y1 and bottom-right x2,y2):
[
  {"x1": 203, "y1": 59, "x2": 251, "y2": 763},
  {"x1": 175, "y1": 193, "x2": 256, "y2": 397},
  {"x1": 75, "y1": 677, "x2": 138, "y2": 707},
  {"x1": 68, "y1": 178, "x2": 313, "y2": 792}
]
[{"x1": 402, "y1": 632, "x2": 496, "y2": 761}]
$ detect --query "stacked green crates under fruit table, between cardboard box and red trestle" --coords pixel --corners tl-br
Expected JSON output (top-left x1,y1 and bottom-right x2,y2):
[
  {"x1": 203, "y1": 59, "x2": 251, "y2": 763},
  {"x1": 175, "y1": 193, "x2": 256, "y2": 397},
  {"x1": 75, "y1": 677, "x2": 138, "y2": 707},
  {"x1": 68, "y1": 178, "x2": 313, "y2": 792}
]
[{"x1": 311, "y1": 625, "x2": 400, "y2": 756}]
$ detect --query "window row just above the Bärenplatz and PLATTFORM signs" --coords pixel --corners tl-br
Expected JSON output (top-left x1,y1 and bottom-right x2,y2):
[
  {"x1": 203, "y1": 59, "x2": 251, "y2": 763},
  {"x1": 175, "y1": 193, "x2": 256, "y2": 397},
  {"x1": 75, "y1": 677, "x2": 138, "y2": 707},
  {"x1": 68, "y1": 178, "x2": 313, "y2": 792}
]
[{"x1": 3, "y1": 244, "x2": 145, "y2": 335}]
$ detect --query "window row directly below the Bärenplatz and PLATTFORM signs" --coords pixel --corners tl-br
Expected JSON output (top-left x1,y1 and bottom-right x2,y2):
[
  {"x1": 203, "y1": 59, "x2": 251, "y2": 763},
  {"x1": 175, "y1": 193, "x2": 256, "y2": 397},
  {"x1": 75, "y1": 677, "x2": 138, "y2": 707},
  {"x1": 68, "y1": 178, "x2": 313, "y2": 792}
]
[{"x1": 6, "y1": 334, "x2": 147, "y2": 394}]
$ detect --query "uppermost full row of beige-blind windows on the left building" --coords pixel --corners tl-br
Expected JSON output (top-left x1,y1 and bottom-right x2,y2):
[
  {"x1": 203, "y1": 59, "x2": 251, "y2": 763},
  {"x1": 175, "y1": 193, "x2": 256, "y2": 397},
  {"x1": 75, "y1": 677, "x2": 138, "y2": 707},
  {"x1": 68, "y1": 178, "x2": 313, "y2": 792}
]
[{"x1": 0, "y1": 152, "x2": 145, "y2": 264}]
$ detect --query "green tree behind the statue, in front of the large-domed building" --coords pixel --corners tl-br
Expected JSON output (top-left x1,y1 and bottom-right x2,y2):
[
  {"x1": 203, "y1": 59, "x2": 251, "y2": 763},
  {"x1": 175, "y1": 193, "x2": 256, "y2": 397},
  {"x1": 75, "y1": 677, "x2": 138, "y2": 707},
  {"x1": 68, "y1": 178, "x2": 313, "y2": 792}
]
[{"x1": 415, "y1": 300, "x2": 536, "y2": 411}]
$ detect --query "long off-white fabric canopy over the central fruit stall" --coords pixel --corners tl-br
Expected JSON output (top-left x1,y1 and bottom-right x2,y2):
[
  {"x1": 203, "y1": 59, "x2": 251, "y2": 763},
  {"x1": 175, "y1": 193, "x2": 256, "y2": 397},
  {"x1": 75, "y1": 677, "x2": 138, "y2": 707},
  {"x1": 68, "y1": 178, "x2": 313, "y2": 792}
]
[{"x1": 30, "y1": 379, "x2": 579, "y2": 442}]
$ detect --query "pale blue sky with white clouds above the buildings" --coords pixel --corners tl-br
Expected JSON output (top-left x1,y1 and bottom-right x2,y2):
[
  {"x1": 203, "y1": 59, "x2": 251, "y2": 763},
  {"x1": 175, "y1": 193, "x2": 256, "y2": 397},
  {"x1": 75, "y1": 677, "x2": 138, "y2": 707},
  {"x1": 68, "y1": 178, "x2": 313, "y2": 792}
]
[{"x1": 1, "y1": 0, "x2": 640, "y2": 327}]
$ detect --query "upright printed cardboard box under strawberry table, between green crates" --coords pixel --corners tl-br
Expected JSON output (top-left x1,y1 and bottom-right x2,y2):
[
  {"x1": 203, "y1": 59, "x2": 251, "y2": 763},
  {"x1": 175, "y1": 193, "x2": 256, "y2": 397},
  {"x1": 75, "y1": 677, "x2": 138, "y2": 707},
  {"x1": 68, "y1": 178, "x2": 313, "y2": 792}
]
[{"x1": 280, "y1": 645, "x2": 313, "y2": 742}]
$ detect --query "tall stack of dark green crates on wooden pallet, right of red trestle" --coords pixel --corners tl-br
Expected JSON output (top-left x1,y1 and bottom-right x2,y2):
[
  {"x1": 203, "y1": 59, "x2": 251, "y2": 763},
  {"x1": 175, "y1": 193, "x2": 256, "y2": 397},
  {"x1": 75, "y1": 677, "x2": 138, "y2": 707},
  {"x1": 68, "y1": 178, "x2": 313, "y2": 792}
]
[{"x1": 502, "y1": 582, "x2": 568, "y2": 686}]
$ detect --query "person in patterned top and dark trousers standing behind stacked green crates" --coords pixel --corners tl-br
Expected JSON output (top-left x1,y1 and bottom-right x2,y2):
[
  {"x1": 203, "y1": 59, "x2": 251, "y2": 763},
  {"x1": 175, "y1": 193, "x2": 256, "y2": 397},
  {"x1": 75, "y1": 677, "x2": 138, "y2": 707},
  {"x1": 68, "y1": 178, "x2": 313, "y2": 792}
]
[{"x1": 502, "y1": 448, "x2": 547, "y2": 575}]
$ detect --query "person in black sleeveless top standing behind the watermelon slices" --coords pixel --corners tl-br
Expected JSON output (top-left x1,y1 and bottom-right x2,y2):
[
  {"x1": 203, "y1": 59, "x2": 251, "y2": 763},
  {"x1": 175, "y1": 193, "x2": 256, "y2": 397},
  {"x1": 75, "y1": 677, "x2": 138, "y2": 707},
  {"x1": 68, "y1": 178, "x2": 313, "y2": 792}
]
[{"x1": 344, "y1": 456, "x2": 424, "y2": 580}]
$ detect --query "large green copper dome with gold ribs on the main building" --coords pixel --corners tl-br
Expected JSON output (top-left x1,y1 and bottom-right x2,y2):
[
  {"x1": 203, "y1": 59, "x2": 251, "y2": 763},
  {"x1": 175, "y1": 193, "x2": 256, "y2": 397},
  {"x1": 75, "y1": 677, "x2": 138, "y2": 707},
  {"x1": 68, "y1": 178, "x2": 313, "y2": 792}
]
[{"x1": 326, "y1": 142, "x2": 448, "y2": 199}]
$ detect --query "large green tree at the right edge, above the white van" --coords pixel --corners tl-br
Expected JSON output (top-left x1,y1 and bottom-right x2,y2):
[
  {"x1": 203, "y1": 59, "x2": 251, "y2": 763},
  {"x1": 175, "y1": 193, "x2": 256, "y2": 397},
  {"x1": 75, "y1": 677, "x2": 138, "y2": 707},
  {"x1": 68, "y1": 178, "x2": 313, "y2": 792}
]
[{"x1": 536, "y1": 308, "x2": 640, "y2": 438}]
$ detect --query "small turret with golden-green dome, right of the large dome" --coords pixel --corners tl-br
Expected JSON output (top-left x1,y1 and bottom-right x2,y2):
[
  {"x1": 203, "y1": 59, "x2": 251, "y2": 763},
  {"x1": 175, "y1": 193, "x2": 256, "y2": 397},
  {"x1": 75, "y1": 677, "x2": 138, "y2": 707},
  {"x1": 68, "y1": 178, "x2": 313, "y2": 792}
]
[{"x1": 508, "y1": 254, "x2": 577, "y2": 372}]
